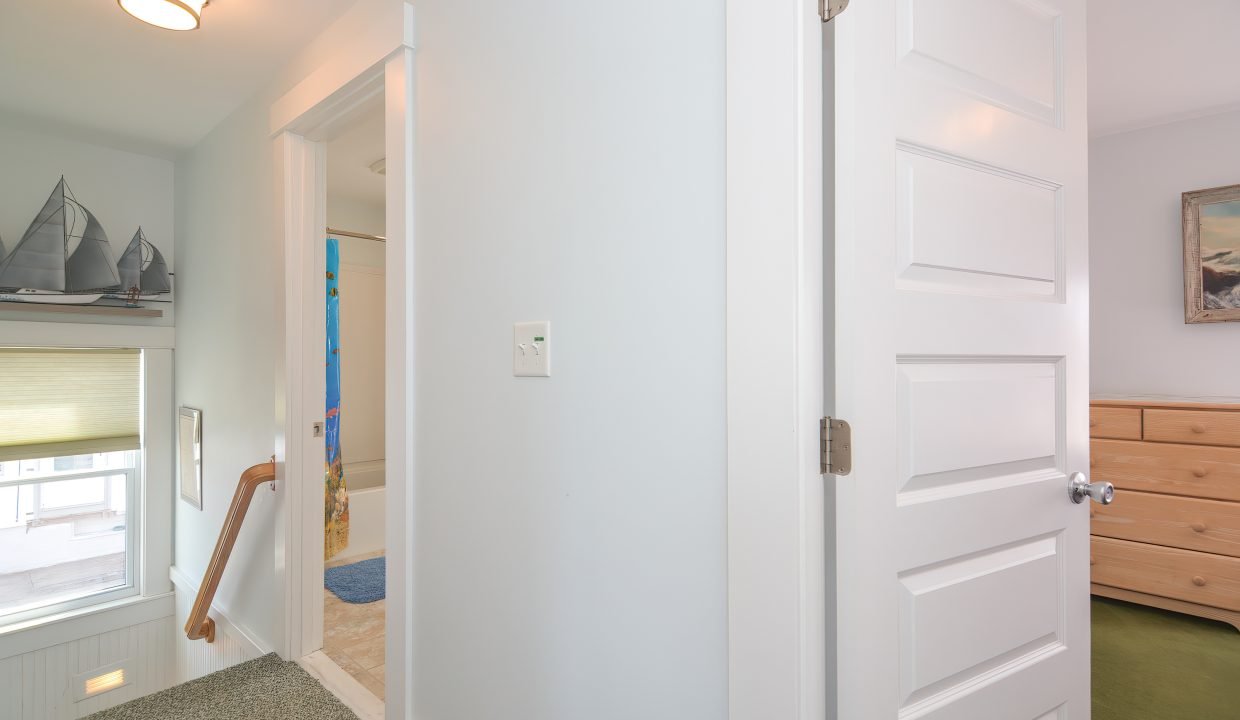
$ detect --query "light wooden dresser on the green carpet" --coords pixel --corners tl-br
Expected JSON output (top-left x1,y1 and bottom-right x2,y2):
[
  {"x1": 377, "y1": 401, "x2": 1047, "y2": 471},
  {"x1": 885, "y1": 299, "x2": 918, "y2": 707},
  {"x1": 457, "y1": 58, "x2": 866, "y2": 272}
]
[{"x1": 1090, "y1": 400, "x2": 1240, "y2": 630}]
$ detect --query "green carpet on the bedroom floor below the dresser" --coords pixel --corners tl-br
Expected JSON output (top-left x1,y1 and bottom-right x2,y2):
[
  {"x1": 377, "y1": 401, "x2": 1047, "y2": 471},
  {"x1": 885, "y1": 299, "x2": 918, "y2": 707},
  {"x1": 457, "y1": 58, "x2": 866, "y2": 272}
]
[{"x1": 1092, "y1": 597, "x2": 1240, "y2": 720}]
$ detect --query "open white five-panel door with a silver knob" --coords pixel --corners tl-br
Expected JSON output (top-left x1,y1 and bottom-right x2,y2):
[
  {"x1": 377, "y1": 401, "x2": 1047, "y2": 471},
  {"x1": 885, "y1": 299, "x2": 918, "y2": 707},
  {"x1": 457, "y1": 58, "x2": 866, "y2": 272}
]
[{"x1": 828, "y1": 0, "x2": 1090, "y2": 720}]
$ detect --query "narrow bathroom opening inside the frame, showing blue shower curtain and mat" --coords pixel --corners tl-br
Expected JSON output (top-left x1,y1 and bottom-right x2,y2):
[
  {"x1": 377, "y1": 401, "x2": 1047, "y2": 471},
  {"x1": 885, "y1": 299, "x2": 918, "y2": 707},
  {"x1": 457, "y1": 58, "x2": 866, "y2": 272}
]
[{"x1": 319, "y1": 95, "x2": 387, "y2": 700}]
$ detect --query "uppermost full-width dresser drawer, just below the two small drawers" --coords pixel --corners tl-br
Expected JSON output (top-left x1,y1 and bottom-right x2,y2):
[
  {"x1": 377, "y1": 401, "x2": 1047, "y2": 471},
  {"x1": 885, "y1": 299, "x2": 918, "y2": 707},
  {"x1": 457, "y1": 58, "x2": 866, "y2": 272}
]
[{"x1": 1089, "y1": 440, "x2": 1240, "y2": 502}]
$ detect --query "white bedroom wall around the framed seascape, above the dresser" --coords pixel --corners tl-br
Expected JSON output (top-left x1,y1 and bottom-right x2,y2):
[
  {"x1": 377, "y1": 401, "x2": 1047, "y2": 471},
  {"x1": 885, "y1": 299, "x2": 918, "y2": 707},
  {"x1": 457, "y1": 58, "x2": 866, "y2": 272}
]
[{"x1": 1090, "y1": 113, "x2": 1240, "y2": 399}]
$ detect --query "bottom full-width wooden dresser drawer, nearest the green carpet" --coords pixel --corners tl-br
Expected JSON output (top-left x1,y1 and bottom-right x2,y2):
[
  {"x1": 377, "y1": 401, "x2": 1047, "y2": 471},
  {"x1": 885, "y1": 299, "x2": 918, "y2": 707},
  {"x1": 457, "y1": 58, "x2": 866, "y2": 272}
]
[{"x1": 1090, "y1": 537, "x2": 1240, "y2": 611}]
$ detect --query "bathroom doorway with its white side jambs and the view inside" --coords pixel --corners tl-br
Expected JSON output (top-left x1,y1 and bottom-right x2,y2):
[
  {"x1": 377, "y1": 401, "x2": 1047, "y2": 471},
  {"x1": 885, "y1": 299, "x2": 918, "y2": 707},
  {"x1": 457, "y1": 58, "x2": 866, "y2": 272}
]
[{"x1": 272, "y1": 47, "x2": 414, "y2": 720}]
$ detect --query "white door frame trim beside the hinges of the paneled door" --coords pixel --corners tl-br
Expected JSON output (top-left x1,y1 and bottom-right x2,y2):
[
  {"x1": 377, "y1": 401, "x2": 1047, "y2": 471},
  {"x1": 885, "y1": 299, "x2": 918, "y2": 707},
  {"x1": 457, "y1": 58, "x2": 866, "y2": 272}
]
[{"x1": 725, "y1": 0, "x2": 835, "y2": 720}]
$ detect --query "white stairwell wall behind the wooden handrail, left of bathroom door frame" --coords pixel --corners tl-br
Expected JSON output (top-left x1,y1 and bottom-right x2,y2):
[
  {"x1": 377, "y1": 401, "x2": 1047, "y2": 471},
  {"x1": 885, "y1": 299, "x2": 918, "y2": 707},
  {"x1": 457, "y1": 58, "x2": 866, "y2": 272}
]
[{"x1": 175, "y1": 88, "x2": 284, "y2": 649}]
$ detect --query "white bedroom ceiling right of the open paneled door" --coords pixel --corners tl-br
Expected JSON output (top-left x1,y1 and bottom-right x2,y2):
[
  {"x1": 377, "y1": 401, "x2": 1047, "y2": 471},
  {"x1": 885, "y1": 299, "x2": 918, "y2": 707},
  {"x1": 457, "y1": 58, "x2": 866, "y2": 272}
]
[{"x1": 1089, "y1": 0, "x2": 1240, "y2": 136}]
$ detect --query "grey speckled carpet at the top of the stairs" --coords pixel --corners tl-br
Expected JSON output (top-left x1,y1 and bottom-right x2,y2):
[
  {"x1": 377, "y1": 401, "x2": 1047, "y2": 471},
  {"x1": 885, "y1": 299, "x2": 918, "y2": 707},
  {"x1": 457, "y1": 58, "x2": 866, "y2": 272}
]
[{"x1": 87, "y1": 654, "x2": 357, "y2": 720}]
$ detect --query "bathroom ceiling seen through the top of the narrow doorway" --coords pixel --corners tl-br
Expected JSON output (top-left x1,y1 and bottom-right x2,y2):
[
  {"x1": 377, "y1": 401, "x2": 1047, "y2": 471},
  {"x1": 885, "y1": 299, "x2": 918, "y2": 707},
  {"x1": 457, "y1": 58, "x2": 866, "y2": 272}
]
[{"x1": 327, "y1": 95, "x2": 387, "y2": 208}]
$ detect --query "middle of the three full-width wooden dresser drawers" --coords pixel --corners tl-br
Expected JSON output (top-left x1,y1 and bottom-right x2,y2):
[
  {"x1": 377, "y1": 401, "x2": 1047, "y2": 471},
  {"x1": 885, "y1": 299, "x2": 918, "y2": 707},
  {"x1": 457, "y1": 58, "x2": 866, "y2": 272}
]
[{"x1": 1090, "y1": 491, "x2": 1240, "y2": 558}]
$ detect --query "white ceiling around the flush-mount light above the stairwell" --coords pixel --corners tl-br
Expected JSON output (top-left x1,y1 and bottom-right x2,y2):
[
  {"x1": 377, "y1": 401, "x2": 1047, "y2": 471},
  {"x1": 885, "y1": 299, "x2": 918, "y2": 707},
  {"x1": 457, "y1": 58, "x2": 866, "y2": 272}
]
[{"x1": 0, "y1": 0, "x2": 350, "y2": 155}]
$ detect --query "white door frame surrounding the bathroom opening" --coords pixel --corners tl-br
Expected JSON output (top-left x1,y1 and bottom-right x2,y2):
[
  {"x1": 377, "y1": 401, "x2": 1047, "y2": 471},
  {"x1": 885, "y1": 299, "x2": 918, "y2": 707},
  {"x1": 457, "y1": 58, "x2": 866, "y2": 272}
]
[{"x1": 270, "y1": 1, "x2": 414, "y2": 718}]
